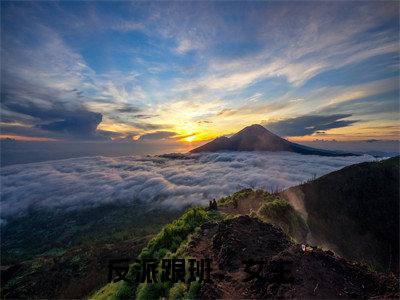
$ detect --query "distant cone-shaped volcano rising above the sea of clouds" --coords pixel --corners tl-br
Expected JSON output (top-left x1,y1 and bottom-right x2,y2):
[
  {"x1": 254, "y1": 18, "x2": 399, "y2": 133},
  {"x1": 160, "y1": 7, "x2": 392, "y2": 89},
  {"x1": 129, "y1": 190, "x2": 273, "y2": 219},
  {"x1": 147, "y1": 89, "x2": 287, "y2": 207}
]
[{"x1": 190, "y1": 124, "x2": 354, "y2": 156}]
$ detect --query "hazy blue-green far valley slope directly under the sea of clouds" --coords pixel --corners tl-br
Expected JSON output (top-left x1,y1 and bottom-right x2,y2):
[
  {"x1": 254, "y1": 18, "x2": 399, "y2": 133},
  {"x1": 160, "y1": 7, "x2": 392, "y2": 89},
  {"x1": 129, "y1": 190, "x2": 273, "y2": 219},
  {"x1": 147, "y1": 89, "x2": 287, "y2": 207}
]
[{"x1": 1, "y1": 202, "x2": 182, "y2": 265}]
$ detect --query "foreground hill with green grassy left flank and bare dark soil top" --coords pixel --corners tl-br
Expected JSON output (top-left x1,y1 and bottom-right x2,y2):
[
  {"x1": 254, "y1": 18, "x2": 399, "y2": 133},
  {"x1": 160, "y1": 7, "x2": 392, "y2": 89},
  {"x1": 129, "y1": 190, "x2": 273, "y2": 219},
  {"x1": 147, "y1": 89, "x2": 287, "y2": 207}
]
[{"x1": 90, "y1": 209, "x2": 398, "y2": 299}]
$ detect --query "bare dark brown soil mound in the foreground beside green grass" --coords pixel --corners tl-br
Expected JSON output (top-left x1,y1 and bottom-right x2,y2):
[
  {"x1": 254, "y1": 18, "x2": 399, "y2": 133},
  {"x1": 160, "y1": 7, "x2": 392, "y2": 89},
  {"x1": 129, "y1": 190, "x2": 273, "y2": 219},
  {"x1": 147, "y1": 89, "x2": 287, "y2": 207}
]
[{"x1": 188, "y1": 216, "x2": 399, "y2": 299}]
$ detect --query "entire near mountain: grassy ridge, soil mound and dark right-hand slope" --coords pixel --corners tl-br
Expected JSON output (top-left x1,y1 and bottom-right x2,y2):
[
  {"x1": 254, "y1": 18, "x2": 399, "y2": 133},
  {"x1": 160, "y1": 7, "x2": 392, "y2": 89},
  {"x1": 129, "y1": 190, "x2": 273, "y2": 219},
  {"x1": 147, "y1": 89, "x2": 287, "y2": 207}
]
[{"x1": 91, "y1": 157, "x2": 399, "y2": 299}]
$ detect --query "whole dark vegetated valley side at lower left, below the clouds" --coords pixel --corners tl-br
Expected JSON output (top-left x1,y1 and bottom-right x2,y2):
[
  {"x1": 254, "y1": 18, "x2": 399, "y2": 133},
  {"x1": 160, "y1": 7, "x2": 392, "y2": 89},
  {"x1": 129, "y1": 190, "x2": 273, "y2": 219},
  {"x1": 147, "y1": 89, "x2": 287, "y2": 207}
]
[{"x1": 1, "y1": 202, "x2": 182, "y2": 298}]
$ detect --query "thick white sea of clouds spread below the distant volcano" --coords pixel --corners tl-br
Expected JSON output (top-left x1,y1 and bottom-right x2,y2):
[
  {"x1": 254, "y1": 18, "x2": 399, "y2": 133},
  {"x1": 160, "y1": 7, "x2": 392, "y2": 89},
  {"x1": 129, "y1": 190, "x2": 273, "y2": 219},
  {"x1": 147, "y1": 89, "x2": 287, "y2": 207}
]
[{"x1": 0, "y1": 152, "x2": 374, "y2": 222}]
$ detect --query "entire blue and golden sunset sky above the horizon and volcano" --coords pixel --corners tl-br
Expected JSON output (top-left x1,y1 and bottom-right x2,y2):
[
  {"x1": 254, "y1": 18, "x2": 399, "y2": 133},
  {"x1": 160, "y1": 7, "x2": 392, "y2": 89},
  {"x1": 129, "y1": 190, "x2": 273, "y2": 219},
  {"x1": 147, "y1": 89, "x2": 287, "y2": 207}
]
[{"x1": 0, "y1": 1, "x2": 400, "y2": 155}]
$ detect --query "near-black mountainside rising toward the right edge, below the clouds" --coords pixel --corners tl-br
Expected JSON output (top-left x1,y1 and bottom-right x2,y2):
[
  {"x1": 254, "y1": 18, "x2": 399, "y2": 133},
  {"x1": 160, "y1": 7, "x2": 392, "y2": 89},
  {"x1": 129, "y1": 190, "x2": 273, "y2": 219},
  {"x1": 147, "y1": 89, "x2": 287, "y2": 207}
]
[{"x1": 282, "y1": 157, "x2": 399, "y2": 273}]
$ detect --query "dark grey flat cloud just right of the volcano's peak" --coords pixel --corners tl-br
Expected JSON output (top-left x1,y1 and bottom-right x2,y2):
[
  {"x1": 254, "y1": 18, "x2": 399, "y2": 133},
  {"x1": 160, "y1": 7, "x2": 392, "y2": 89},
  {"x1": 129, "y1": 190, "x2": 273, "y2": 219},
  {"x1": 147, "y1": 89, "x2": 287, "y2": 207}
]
[{"x1": 265, "y1": 114, "x2": 357, "y2": 136}]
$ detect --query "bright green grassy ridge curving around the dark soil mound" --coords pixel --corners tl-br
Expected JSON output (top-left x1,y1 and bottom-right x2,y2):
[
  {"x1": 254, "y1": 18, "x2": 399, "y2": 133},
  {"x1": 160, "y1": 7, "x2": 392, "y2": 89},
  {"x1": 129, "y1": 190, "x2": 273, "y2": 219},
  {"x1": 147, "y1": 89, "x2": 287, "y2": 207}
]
[{"x1": 90, "y1": 189, "x2": 306, "y2": 299}]
